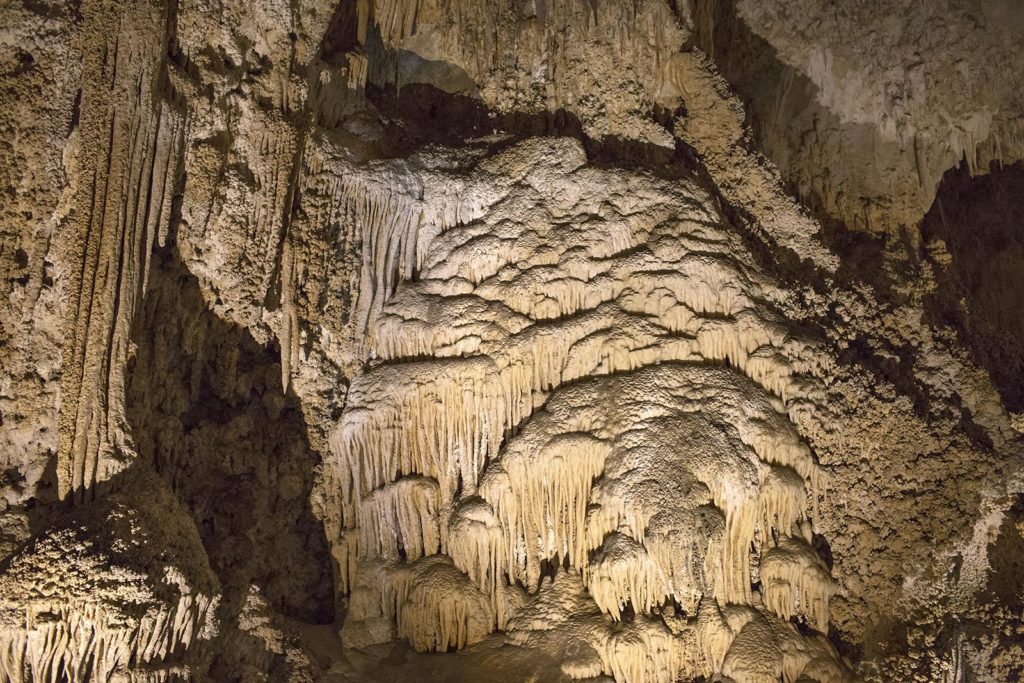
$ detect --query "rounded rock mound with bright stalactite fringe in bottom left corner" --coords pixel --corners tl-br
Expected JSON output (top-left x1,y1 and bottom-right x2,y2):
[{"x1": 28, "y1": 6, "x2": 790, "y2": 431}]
[{"x1": 0, "y1": 477, "x2": 220, "y2": 681}]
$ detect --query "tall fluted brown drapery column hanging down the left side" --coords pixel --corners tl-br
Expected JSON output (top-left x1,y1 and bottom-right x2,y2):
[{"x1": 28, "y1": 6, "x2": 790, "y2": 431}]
[{"x1": 57, "y1": 5, "x2": 183, "y2": 502}]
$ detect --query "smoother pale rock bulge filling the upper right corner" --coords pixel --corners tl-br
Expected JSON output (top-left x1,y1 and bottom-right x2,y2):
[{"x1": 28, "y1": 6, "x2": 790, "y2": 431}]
[{"x1": 693, "y1": 0, "x2": 1024, "y2": 234}]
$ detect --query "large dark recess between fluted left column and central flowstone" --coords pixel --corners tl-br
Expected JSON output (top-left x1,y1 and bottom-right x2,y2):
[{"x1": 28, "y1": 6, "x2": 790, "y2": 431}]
[{"x1": 127, "y1": 237, "x2": 334, "y2": 638}]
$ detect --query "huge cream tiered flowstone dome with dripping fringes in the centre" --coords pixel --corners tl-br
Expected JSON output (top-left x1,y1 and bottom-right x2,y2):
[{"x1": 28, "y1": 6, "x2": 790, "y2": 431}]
[{"x1": 328, "y1": 138, "x2": 845, "y2": 681}]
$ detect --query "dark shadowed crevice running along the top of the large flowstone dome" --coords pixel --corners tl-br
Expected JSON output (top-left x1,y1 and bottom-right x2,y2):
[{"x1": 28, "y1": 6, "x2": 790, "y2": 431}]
[{"x1": 317, "y1": 0, "x2": 847, "y2": 294}]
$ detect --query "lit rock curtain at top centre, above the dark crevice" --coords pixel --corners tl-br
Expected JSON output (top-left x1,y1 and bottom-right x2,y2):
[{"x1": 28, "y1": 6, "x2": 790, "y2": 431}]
[{"x1": 364, "y1": 0, "x2": 686, "y2": 147}]
